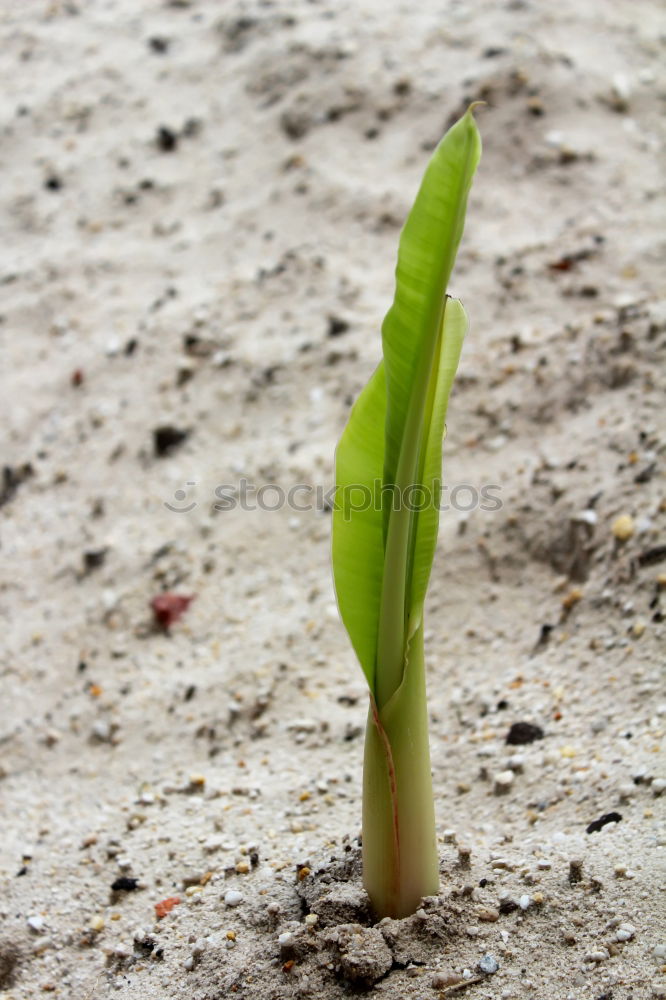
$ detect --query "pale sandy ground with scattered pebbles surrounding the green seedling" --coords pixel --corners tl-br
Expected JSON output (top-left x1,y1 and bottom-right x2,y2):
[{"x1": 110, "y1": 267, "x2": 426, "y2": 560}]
[{"x1": 0, "y1": 0, "x2": 666, "y2": 1000}]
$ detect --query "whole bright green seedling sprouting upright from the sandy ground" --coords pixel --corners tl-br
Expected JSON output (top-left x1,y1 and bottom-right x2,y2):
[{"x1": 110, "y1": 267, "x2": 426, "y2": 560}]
[{"x1": 333, "y1": 106, "x2": 481, "y2": 917}]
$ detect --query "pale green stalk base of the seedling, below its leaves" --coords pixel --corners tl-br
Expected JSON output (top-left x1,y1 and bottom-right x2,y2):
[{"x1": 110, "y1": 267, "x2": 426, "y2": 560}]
[{"x1": 363, "y1": 625, "x2": 439, "y2": 918}]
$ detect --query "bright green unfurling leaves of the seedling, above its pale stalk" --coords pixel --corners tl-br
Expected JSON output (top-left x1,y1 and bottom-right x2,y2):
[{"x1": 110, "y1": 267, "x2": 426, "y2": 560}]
[{"x1": 333, "y1": 111, "x2": 481, "y2": 704}]
